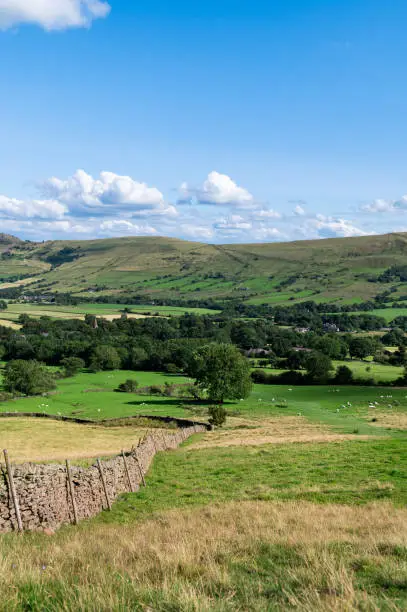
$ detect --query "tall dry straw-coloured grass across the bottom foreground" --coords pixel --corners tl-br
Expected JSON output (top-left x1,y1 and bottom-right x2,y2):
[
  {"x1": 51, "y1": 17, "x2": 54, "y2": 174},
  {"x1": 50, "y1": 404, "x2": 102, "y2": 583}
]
[{"x1": 0, "y1": 502, "x2": 407, "y2": 611}]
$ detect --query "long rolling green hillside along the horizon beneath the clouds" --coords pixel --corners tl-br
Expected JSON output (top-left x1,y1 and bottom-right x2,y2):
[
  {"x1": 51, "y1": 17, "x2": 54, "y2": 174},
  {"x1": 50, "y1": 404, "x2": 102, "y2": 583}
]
[{"x1": 0, "y1": 233, "x2": 407, "y2": 304}]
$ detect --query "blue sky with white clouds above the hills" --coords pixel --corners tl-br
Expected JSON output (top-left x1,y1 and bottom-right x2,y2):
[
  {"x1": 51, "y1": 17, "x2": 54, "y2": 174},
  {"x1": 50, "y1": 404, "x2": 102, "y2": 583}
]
[{"x1": 0, "y1": 0, "x2": 407, "y2": 242}]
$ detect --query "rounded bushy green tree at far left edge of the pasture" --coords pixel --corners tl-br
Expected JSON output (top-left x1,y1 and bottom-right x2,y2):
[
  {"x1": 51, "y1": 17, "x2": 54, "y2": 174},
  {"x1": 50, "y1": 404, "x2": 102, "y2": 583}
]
[{"x1": 3, "y1": 359, "x2": 56, "y2": 395}]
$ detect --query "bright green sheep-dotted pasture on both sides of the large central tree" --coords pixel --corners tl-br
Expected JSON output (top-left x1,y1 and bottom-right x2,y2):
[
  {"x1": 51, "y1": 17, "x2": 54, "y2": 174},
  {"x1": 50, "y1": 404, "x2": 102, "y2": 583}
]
[{"x1": 0, "y1": 370, "x2": 407, "y2": 436}]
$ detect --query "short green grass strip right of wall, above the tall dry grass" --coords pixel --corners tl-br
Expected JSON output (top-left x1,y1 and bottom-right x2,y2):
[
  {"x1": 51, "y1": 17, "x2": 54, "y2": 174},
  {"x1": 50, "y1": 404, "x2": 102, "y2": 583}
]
[{"x1": 101, "y1": 440, "x2": 407, "y2": 523}]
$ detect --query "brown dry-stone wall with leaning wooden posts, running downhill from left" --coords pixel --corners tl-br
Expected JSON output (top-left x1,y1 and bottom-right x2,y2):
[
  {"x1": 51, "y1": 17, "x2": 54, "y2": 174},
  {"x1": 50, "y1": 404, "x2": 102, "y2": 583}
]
[{"x1": 0, "y1": 423, "x2": 208, "y2": 532}]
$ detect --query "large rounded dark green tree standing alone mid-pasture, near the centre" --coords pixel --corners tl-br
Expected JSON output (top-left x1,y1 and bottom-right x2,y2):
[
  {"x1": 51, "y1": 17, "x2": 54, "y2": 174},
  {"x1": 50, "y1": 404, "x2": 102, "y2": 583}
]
[{"x1": 190, "y1": 343, "x2": 252, "y2": 404}]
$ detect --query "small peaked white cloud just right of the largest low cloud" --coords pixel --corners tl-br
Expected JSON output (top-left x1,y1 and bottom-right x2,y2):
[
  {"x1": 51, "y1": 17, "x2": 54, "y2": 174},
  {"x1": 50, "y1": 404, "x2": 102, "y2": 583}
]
[{"x1": 178, "y1": 172, "x2": 257, "y2": 209}]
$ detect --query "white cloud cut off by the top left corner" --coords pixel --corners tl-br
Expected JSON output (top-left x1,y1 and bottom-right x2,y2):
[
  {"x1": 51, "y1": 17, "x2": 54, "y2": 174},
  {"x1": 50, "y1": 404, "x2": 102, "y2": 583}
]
[{"x1": 0, "y1": 0, "x2": 110, "y2": 30}]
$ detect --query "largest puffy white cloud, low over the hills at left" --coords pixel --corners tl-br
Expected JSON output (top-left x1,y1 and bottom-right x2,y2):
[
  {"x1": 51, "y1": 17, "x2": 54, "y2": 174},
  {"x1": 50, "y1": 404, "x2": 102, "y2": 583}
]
[{"x1": 39, "y1": 170, "x2": 176, "y2": 216}]
